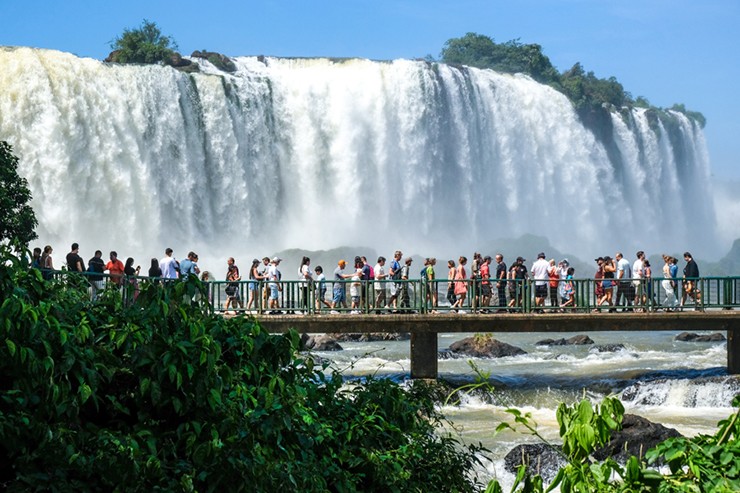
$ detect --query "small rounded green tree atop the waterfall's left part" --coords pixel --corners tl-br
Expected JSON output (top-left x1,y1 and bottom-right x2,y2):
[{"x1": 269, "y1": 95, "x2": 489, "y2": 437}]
[{"x1": 110, "y1": 19, "x2": 177, "y2": 63}]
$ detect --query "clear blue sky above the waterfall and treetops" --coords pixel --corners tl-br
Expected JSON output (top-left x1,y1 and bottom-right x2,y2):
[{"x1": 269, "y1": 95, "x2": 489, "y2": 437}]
[{"x1": 0, "y1": 0, "x2": 740, "y2": 183}]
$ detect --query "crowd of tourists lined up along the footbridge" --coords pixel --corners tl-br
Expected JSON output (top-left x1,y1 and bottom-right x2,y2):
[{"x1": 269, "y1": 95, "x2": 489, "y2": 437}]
[{"x1": 27, "y1": 243, "x2": 701, "y2": 313}]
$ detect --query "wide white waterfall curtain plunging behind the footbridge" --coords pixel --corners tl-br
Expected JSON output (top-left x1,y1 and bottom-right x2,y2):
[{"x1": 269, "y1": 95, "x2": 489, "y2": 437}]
[{"x1": 0, "y1": 48, "x2": 714, "y2": 266}]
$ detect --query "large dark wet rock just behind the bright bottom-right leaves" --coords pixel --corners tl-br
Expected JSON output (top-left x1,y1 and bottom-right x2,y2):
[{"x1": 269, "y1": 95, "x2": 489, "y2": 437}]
[{"x1": 594, "y1": 414, "x2": 682, "y2": 464}]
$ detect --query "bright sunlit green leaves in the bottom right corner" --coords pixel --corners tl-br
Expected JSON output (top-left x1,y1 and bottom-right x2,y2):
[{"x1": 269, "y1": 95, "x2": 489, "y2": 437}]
[{"x1": 486, "y1": 397, "x2": 740, "y2": 493}]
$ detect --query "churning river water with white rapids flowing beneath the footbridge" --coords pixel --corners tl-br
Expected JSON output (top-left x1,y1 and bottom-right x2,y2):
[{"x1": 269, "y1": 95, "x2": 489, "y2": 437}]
[{"x1": 326, "y1": 330, "x2": 740, "y2": 491}]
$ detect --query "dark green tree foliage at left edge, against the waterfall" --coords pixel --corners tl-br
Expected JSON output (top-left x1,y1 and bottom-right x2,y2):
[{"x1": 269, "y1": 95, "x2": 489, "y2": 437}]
[{"x1": 0, "y1": 141, "x2": 38, "y2": 247}]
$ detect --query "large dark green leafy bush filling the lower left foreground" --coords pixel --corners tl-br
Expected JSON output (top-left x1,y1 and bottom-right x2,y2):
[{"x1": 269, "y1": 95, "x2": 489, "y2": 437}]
[{"x1": 0, "y1": 249, "x2": 486, "y2": 492}]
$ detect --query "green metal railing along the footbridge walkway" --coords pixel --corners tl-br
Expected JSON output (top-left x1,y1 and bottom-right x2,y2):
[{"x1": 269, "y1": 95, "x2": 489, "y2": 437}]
[{"x1": 42, "y1": 270, "x2": 740, "y2": 315}]
